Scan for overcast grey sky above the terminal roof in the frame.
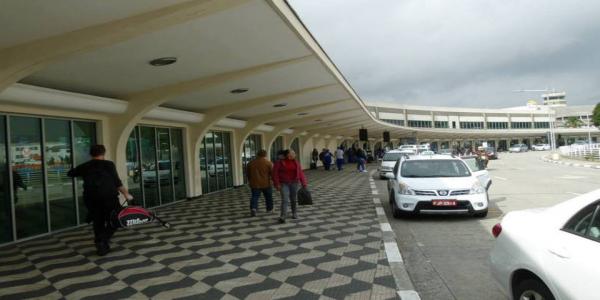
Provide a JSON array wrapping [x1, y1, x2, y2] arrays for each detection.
[[288, 0, 600, 108]]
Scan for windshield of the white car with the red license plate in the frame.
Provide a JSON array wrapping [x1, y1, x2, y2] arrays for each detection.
[[401, 159, 471, 178]]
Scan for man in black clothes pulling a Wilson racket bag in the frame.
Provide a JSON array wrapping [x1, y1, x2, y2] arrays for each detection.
[[67, 145, 133, 256]]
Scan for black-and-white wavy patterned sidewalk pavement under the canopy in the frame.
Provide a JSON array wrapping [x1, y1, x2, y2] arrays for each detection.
[[0, 168, 397, 299]]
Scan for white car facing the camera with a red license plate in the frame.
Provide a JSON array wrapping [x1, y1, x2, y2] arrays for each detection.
[[385, 155, 488, 218]]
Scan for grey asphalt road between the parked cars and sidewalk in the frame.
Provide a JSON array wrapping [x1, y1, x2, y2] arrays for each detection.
[[375, 152, 600, 300]]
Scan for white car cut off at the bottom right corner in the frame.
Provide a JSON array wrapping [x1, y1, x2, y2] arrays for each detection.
[[490, 190, 600, 300]]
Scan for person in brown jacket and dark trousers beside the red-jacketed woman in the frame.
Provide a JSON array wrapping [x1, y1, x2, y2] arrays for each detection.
[[246, 149, 273, 217]]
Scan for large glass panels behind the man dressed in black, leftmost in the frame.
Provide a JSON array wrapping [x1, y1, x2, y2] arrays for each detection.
[[0, 115, 96, 243]]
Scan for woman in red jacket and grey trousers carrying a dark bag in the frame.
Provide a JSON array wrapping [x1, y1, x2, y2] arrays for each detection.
[[273, 150, 306, 223]]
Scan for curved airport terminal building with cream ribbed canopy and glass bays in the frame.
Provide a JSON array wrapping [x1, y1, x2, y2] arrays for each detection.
[[0, 0, 598, 244]]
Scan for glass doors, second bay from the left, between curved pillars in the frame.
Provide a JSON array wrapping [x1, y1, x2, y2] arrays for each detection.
[[125, 126, 186, 207]]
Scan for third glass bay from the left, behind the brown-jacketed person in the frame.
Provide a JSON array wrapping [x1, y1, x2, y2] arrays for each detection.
[[200, 131, 233, 193]]
